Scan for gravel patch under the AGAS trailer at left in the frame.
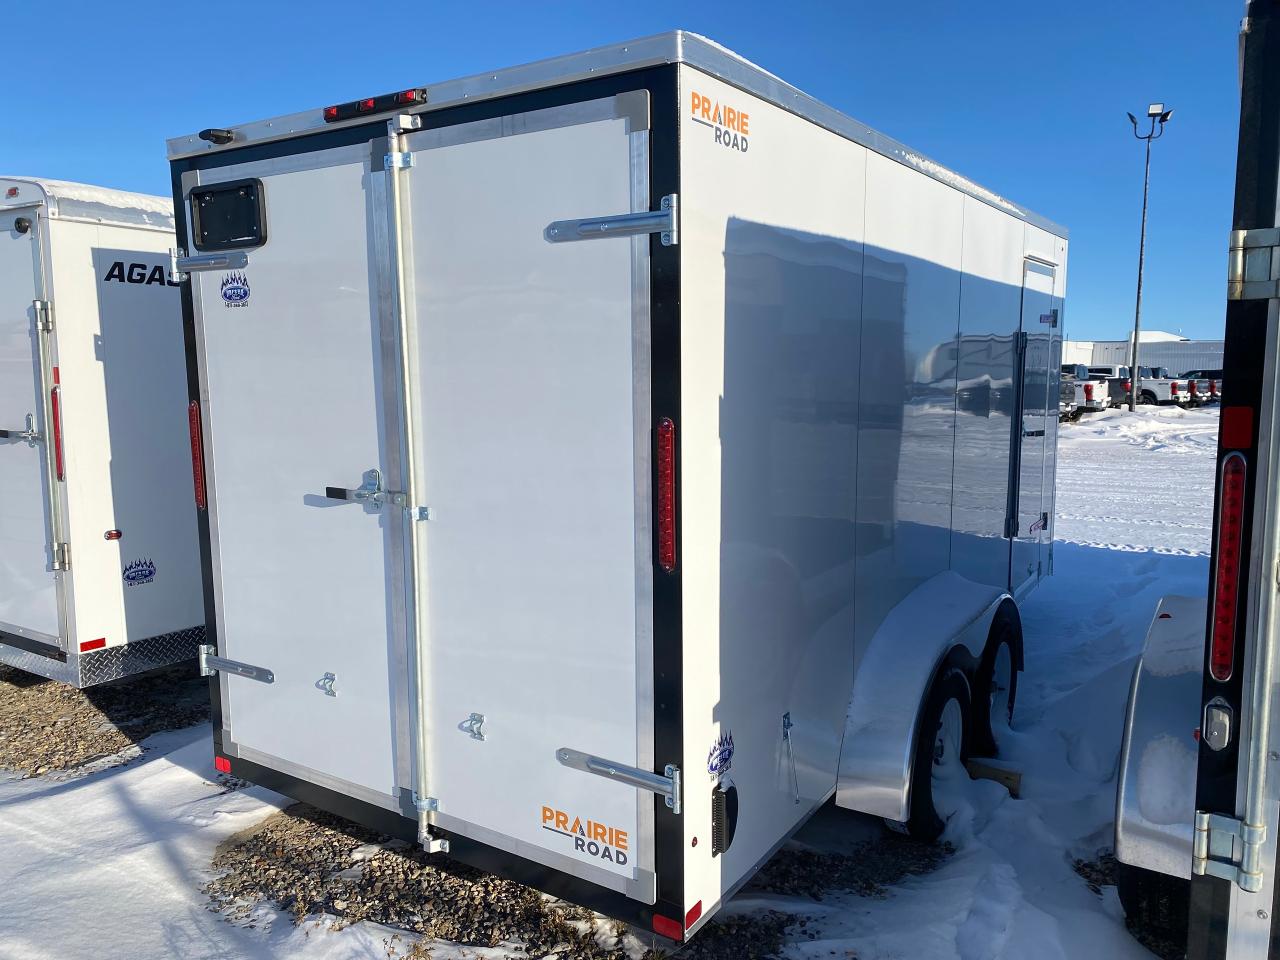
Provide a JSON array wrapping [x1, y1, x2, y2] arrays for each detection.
[[0, 664, 209, 777]]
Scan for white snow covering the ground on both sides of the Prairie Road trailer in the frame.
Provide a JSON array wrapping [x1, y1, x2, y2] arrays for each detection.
[[0, 408, 1217, 960]]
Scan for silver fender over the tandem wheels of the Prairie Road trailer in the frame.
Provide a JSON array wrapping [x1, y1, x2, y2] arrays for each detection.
[[836, 571, 1020, 822]]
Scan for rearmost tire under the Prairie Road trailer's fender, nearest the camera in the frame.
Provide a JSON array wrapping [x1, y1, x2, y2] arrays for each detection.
[[906, 667, 972, 844]]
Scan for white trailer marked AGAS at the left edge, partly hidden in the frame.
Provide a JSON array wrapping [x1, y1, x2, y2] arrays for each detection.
[[0, 177, 205, 687]]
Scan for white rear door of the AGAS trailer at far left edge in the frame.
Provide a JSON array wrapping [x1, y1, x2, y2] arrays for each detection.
[[0, 206, 61, 649]]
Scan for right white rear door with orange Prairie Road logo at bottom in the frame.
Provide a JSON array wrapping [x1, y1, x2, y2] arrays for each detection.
[[407, 93, 658, 902]]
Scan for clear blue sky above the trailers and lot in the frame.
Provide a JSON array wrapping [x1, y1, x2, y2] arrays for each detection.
[[0, 0, 1243, 339]]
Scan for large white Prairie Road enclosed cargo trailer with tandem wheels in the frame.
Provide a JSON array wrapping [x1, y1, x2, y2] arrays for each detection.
[[169, 33, 1066, 938]]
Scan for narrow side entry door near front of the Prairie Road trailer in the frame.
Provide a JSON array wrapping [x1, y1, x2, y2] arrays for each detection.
[[1009, 260, 1057, 593]]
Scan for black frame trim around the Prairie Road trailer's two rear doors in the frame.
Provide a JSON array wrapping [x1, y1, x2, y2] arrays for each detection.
[[170, 64, 685, 931]]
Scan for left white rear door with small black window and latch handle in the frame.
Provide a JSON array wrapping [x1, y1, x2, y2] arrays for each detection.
[[183, 145, 404, 809]]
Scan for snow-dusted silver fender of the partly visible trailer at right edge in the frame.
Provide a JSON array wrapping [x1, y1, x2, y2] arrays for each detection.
[[1115, 596, 1207, 879]]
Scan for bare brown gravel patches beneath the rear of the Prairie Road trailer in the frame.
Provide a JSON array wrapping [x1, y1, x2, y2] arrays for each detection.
[[205, 804, 950, 960]]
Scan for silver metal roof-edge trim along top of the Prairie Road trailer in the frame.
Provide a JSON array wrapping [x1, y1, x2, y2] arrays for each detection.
[[168, 31, 1068, 238]]
